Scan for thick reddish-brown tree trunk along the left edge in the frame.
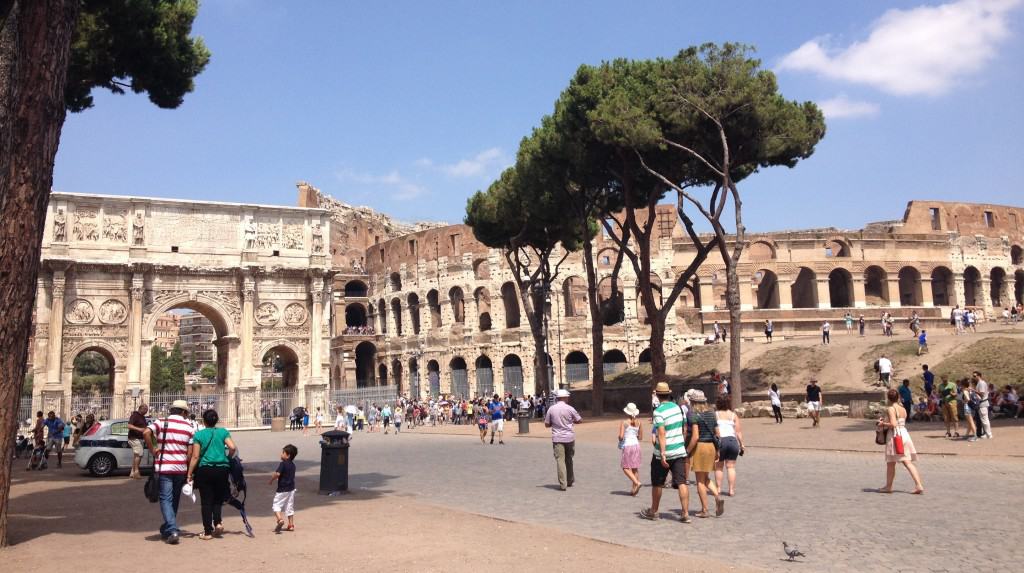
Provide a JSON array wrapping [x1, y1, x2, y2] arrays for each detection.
[[0, 0, 80, 545]]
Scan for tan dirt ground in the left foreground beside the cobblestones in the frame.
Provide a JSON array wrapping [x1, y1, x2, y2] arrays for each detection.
[[0, 464, 750, 573]]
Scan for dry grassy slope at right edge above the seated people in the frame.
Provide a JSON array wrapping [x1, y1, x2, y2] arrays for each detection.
[[932, 338, 1024, 388]]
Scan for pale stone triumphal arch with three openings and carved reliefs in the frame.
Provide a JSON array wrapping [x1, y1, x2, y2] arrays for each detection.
[[32, 192, 332, 420]]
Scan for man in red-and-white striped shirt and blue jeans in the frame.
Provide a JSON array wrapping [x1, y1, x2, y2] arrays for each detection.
[[142, 400, 196, 545]]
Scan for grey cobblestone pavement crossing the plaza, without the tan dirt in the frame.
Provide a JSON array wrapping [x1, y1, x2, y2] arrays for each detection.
[[238, 430, 1024, 571]]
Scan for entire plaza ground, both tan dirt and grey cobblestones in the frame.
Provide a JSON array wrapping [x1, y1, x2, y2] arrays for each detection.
[[4, 420, 1024, 571]]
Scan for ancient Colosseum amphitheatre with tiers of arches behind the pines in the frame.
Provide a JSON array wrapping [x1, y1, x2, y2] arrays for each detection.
[[309, 184, 1024, 403]]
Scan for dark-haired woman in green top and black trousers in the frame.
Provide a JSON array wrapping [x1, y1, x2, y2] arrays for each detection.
[[188, 410, 234, 540]]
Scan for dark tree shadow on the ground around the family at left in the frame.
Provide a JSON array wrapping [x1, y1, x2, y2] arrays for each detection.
[[8, 468, 397, 545]]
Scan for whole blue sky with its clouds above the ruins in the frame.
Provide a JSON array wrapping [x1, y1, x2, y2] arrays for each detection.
[[54, 0, 1024, 230]]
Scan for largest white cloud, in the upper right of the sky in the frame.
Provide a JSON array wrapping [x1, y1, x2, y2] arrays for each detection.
[[778, 0, 1022, 95]]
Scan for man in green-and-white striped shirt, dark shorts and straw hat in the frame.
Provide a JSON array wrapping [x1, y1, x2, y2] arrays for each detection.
[[640, 382, 697, 523]]
